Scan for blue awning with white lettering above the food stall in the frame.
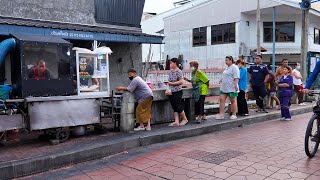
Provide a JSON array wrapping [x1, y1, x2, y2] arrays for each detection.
[[0, 16, 163, 44]]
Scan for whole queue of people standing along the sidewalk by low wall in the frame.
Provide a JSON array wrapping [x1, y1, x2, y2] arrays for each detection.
[[116, 55, 305, 131]]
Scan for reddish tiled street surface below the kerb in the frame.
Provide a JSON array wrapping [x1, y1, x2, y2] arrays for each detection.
[[18, 113, 320, 180]]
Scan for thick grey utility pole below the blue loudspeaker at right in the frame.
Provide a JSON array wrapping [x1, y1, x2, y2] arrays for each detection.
[[301, 9, 309, 82]]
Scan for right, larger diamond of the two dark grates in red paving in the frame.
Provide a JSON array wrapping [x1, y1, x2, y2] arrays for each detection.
[[199, 150, 244, 164]]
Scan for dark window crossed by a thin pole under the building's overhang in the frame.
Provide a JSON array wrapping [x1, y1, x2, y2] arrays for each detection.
[[263, 22, 295, 42]]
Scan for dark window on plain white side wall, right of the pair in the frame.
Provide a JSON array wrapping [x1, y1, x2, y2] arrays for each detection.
[[211, 23, 236, 45]]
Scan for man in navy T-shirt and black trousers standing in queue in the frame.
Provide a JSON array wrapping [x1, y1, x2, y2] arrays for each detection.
[[248, 55, 269, 113]]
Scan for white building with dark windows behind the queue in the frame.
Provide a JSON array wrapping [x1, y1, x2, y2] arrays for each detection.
[[164, 0, 320, 69]]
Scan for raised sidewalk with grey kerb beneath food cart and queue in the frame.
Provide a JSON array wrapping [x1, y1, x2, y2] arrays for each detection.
[[0, 104, 312, 179]]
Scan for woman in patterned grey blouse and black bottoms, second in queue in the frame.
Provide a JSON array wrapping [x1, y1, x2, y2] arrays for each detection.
[[167, 58, 188, 126]]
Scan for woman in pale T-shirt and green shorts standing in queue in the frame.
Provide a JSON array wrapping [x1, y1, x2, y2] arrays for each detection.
[[216, 56, 240, 119]]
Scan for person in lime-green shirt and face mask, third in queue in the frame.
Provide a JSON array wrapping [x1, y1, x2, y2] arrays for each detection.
[[184, 60, 209, 123]]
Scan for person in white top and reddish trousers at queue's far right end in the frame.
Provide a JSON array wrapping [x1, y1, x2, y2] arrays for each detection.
[[292, 63, 306, 106]]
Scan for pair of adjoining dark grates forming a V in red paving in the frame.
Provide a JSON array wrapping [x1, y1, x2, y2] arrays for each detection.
[[181, 150, 244, 164]]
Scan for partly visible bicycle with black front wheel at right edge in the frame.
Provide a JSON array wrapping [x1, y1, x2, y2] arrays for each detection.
[[304, 92, 320, 158]]
